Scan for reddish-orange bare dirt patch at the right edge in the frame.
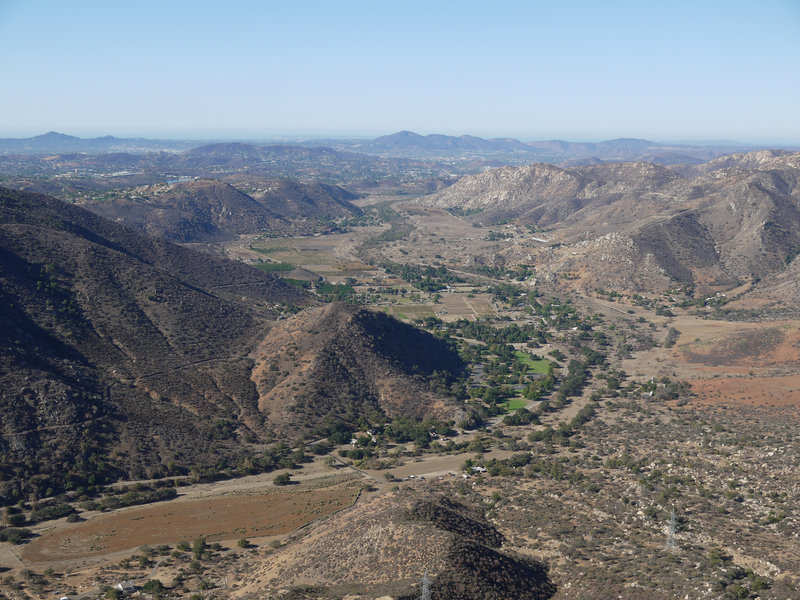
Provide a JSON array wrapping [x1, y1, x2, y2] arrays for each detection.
[[689, 374, 800, 407]]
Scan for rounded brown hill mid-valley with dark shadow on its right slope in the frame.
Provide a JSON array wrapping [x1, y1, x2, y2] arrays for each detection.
[[253, 304, 466, 437]]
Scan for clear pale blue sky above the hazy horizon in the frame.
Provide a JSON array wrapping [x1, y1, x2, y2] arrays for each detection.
[[0, 0, 800, 145]]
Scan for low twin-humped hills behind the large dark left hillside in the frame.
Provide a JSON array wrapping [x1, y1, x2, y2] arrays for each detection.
[[83, 179, 361, 243]]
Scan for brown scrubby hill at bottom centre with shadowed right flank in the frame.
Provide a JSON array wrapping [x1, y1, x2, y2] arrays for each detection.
[[234, 493, 555, 600]]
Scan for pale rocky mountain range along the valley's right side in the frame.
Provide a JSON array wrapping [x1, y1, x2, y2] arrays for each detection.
[[421, 151, 800, 291]]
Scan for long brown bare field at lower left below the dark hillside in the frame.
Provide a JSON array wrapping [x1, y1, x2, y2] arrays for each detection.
[[21, 482, 360, 563]]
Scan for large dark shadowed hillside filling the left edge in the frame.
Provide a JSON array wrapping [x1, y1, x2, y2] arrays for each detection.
[[0, 190, 309, 499]]
